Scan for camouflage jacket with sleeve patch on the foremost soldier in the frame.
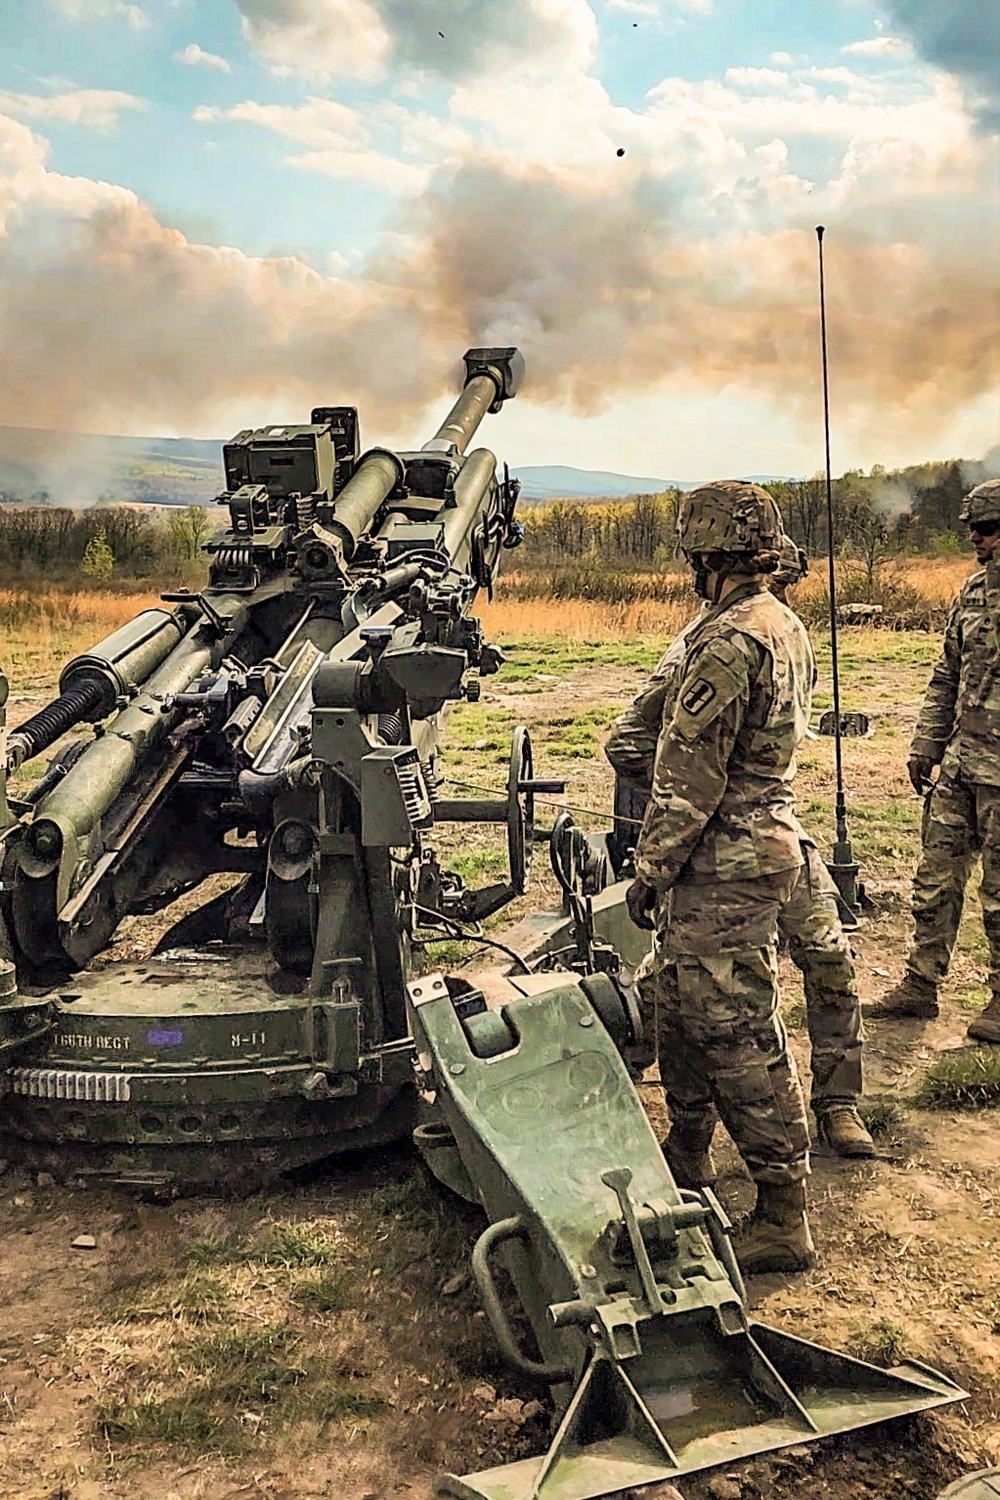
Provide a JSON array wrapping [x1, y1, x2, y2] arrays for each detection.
[[606, 584, 816, 893]]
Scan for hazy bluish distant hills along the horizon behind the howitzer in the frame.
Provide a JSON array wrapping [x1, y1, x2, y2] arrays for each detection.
[[0, 428, 797, 506]]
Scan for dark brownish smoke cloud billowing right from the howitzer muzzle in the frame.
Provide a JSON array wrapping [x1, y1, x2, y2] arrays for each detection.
[[394, 165, 1000, 432]]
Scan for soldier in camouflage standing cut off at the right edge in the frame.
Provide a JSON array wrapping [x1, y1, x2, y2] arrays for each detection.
[[868, 479, 1000, 1043]]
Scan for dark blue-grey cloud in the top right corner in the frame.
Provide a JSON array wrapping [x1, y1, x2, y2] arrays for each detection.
[[889, 0, 1000, 131]]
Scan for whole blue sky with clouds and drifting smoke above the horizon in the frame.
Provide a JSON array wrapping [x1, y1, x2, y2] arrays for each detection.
[[0, 0, 1000, 477]]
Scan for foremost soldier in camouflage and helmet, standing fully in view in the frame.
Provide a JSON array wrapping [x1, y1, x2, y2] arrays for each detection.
[[614, 480, 816, 1272]]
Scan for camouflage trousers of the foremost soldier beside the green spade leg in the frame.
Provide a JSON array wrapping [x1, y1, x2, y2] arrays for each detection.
[[642, 870, 810, 1184]]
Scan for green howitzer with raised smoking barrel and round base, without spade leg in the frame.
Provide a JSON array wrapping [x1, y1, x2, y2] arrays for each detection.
[[0, 348, 560, 1191]]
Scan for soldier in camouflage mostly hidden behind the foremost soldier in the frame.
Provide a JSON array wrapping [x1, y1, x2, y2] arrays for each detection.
[[604, 537, 876, 1164]]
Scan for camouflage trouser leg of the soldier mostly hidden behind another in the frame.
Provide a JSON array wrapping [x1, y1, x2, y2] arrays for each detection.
[[778, 843, 864, 1110]]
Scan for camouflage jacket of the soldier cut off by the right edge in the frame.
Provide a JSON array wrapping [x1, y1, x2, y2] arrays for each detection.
[[910, 563, 1000, 786]]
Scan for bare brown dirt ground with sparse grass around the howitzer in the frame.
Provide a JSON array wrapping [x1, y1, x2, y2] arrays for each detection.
[[0, 633, 1000, 1500]]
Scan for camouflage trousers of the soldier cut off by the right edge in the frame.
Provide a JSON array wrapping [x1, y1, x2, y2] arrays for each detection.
[[907, 779, 1000, 995]]
